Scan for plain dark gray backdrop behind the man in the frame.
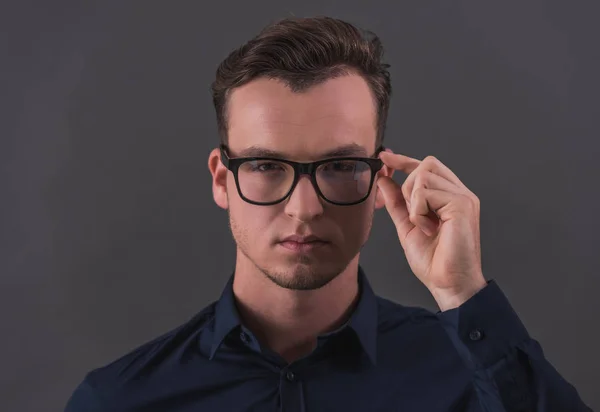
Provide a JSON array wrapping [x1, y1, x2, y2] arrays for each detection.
[[0, 0, 600, 411]]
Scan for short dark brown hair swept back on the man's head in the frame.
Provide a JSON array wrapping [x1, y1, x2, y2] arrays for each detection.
[[211, 17, 392, 146]]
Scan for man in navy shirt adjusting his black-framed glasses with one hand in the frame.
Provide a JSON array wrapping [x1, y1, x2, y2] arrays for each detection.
[[66, 14, 590, 412]]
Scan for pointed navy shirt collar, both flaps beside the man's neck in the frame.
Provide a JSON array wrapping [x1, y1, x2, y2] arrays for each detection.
[[210, 265, 378, 364]]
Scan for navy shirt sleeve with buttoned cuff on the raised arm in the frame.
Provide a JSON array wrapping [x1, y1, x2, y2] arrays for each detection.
[[437, 280, 592, 412]]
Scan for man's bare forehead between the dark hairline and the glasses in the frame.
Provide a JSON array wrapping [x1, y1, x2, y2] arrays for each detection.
[[228, 76, 377, 160]]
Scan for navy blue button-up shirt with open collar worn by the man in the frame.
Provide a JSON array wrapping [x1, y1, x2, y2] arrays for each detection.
[[66, 268, 591, 412]]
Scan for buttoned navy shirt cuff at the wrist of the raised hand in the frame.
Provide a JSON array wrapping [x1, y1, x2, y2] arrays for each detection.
[[437, 279, 530, 367]]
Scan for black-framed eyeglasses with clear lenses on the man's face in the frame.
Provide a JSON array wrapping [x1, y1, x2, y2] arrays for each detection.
[[220, 145, 385, 206]]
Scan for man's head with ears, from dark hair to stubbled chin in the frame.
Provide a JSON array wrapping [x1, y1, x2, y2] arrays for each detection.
[[209, 18, 391, 289]]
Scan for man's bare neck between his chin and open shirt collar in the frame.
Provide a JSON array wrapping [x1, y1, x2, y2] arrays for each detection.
[[233, 256, 358, 363]]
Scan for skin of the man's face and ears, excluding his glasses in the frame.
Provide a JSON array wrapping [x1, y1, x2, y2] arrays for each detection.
[[209, 75, 391, 290]]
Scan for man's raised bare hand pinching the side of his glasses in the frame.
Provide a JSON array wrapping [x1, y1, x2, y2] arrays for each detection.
[[377, 149, 487, 311]]
